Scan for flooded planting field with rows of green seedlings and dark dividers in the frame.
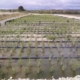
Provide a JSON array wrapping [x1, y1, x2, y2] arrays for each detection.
[[0, 14, 80, 78]]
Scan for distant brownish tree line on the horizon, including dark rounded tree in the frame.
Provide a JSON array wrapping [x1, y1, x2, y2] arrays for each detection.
[[0, 6, 80, 14]]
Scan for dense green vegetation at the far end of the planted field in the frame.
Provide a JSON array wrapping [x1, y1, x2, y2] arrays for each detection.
[[6, 15, 78, 24]]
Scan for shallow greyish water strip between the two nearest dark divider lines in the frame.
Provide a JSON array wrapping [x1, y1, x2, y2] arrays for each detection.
[[0, 47, 80, 57]]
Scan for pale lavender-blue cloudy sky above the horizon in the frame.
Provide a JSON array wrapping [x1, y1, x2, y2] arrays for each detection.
[[0, 0, 80, 10]]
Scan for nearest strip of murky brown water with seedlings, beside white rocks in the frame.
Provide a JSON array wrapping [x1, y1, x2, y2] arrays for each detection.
[[1, 58, 80, 78]]
